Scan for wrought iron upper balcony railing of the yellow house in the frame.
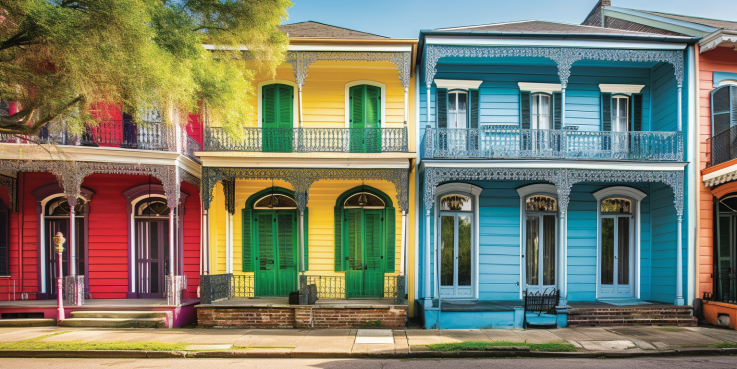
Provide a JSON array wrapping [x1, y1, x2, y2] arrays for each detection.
[[205, 127, 408, 153]]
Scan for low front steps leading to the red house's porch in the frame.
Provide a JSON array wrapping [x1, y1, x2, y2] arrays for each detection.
[[58, 311, 168, 328]]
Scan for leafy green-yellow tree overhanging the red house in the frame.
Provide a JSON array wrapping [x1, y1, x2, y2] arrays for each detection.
[[0, 0, 292, 135]]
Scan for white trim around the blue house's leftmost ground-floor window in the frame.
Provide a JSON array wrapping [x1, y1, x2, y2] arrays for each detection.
[[434, 182, 483, 300]]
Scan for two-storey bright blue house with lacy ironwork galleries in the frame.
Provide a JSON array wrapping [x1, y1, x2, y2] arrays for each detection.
[[416, 21, 697, 329]]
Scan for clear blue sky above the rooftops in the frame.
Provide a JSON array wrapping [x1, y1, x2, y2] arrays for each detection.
[[287, 0, 737, 38]]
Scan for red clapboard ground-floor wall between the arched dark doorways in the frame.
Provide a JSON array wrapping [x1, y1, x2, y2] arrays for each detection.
[[0, 173, 200, 299]]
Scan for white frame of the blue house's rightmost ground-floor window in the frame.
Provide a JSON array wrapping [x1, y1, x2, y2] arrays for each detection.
[[593, 186, 647, 300]]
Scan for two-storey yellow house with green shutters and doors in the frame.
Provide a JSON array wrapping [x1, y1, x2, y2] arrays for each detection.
[[198, 22, 417, 327]]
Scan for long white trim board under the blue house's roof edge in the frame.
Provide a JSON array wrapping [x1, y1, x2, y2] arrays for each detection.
[[425, 35, 688, 50]]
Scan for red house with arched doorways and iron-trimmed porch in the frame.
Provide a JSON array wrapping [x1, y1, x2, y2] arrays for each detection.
[[0, 103, 203, 327]]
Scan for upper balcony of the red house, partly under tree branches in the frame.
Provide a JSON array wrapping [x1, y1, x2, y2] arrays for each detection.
[[0, 120, 200, 162]]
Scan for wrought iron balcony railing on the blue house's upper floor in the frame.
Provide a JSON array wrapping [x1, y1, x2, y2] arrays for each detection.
[[420, 125, 683, 161]]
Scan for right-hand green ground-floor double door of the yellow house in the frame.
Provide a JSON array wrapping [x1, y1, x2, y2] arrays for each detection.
[[345, 209, 384, 298]]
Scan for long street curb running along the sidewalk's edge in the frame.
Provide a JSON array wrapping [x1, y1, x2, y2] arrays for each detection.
[[0, 347, 737, 359]]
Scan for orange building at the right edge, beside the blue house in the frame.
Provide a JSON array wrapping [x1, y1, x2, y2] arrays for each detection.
[[583, 0, 737, 329]]
